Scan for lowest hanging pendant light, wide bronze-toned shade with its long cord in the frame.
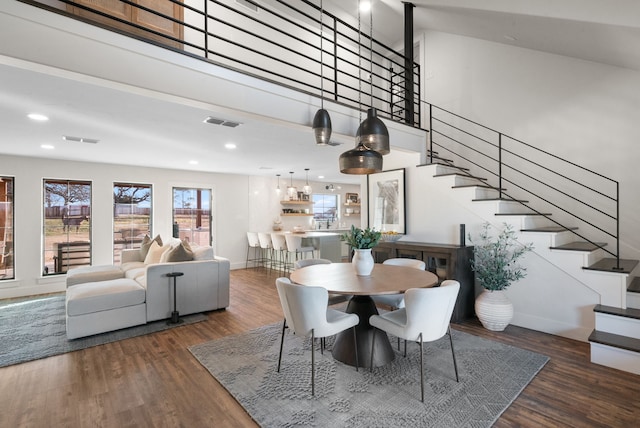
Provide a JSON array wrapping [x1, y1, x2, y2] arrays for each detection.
[[339, 0, 382, 175]]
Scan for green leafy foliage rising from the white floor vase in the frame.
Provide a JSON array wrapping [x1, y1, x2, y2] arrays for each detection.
[[469, 223, 533, 291]]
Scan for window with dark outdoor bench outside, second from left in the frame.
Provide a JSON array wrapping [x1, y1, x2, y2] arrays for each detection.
[[42, 179, 91, 275]]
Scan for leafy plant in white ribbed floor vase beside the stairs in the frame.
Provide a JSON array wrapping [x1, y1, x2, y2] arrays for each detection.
[[469, 223, 533, 331]]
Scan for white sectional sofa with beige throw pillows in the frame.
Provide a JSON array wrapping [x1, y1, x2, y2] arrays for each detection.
[[66, 241, 230, 339]]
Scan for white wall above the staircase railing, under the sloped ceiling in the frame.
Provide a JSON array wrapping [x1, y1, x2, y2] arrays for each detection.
[[421, 32, 640, 259]]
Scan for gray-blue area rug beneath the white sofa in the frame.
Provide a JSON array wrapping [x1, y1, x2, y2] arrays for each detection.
[[0, 294, 207, 367]]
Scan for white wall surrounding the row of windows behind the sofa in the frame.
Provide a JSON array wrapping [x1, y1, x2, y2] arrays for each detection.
[[0, 155, 251, 298]]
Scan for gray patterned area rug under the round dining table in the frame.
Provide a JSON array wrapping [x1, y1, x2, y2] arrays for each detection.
[[189, 323, 549, 428]]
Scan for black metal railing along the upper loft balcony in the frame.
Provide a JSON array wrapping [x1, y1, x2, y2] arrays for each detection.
[[25, 0, 420, 127]]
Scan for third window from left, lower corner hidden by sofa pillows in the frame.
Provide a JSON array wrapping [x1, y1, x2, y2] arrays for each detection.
[[113, 183, 152, 263]]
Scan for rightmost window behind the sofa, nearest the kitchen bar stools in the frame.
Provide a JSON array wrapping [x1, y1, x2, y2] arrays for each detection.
[[173, 187, 213, 246]]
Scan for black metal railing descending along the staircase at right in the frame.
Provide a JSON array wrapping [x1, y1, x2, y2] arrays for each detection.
[[426, 103, 621, 270]]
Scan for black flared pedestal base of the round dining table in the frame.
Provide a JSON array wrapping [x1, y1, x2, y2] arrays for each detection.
[[333, 296, 395, 368]]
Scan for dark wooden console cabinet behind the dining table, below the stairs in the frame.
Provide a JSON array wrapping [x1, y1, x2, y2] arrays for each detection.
[[372, 241, 475, 322]]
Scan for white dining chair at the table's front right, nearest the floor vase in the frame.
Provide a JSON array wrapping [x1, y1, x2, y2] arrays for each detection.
[[369, 280, 460, 402]]
